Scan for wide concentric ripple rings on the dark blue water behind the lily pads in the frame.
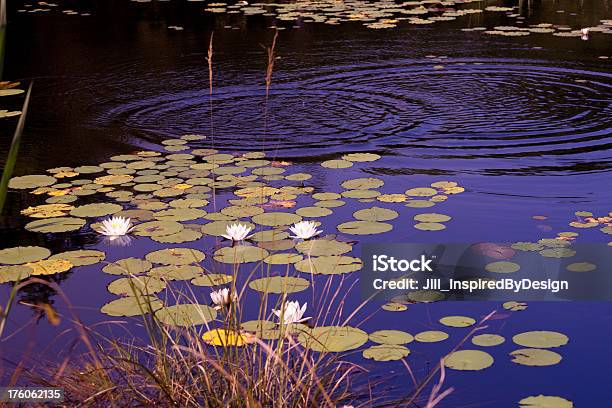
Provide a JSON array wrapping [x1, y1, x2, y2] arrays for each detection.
[[99, 60, 612, 173]]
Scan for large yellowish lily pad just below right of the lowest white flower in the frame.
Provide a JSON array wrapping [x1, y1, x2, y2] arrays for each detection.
[[298, 326, 368, 352]]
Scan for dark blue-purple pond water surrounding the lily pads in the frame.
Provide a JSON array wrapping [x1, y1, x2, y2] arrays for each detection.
[[0, 0, 612, 407]]
